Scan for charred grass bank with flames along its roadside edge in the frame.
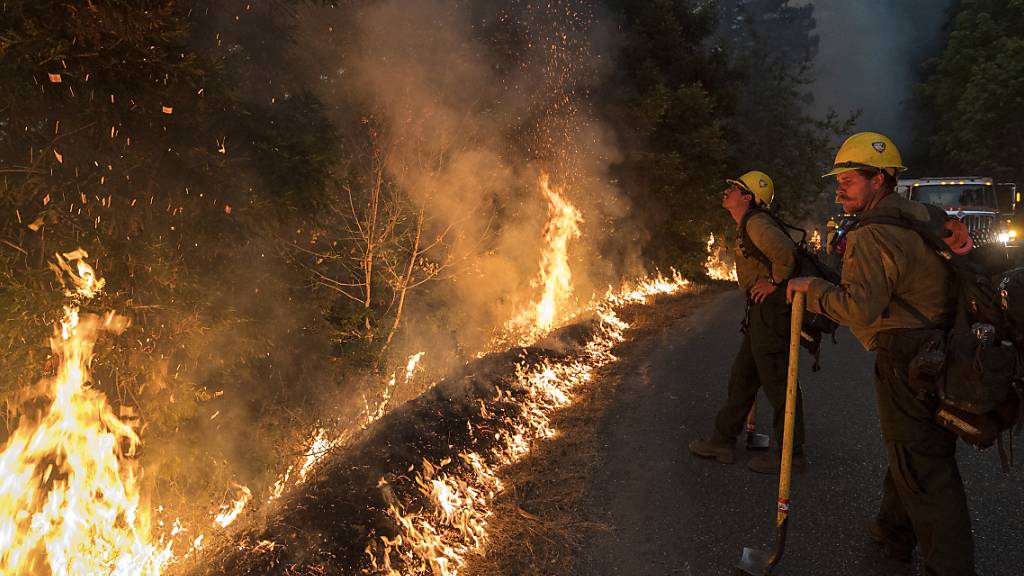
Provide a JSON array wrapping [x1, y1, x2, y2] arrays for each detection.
[[182, 270, 688, 575]]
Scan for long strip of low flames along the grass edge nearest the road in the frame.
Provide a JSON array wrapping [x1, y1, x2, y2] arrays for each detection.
[[366, 271, 690, 576]]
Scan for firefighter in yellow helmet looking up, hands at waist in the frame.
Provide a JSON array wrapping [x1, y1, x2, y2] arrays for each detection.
[[688, 170, 804, 474]]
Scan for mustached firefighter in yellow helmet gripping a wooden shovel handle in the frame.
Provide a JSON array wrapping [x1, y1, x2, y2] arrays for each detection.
[[786, 132, 975, 576]]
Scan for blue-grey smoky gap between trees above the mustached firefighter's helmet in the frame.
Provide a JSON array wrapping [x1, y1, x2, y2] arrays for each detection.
[[803, 0, 952, 155]]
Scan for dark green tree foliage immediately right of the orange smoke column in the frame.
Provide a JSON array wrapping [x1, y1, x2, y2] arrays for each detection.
[[599, 0, 727, 268]]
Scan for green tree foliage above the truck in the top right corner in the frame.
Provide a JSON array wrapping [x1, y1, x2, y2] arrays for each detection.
[[918, 0, 1024, 182]]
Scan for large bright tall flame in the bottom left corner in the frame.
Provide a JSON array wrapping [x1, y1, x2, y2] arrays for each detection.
[[0, 250, 171, 575]]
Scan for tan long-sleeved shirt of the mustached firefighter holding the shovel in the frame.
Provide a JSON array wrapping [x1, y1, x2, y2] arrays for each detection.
[[807, 194, 955, 351]]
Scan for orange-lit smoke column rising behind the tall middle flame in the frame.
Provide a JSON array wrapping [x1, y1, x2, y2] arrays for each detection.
[[299, 0, 638, 361]]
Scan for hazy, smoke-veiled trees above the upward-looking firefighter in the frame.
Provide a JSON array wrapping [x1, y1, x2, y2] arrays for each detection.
[[716, 0, 849, 221]]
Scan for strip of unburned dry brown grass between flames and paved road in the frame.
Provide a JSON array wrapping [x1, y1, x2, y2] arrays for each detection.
[[464, 289, 719, 576]]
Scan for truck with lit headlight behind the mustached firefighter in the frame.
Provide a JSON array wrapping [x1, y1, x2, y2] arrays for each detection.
[[896, 176, 1024, 270]]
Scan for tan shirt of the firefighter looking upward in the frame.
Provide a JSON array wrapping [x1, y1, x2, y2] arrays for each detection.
[[732, 211, 796, 295]]
